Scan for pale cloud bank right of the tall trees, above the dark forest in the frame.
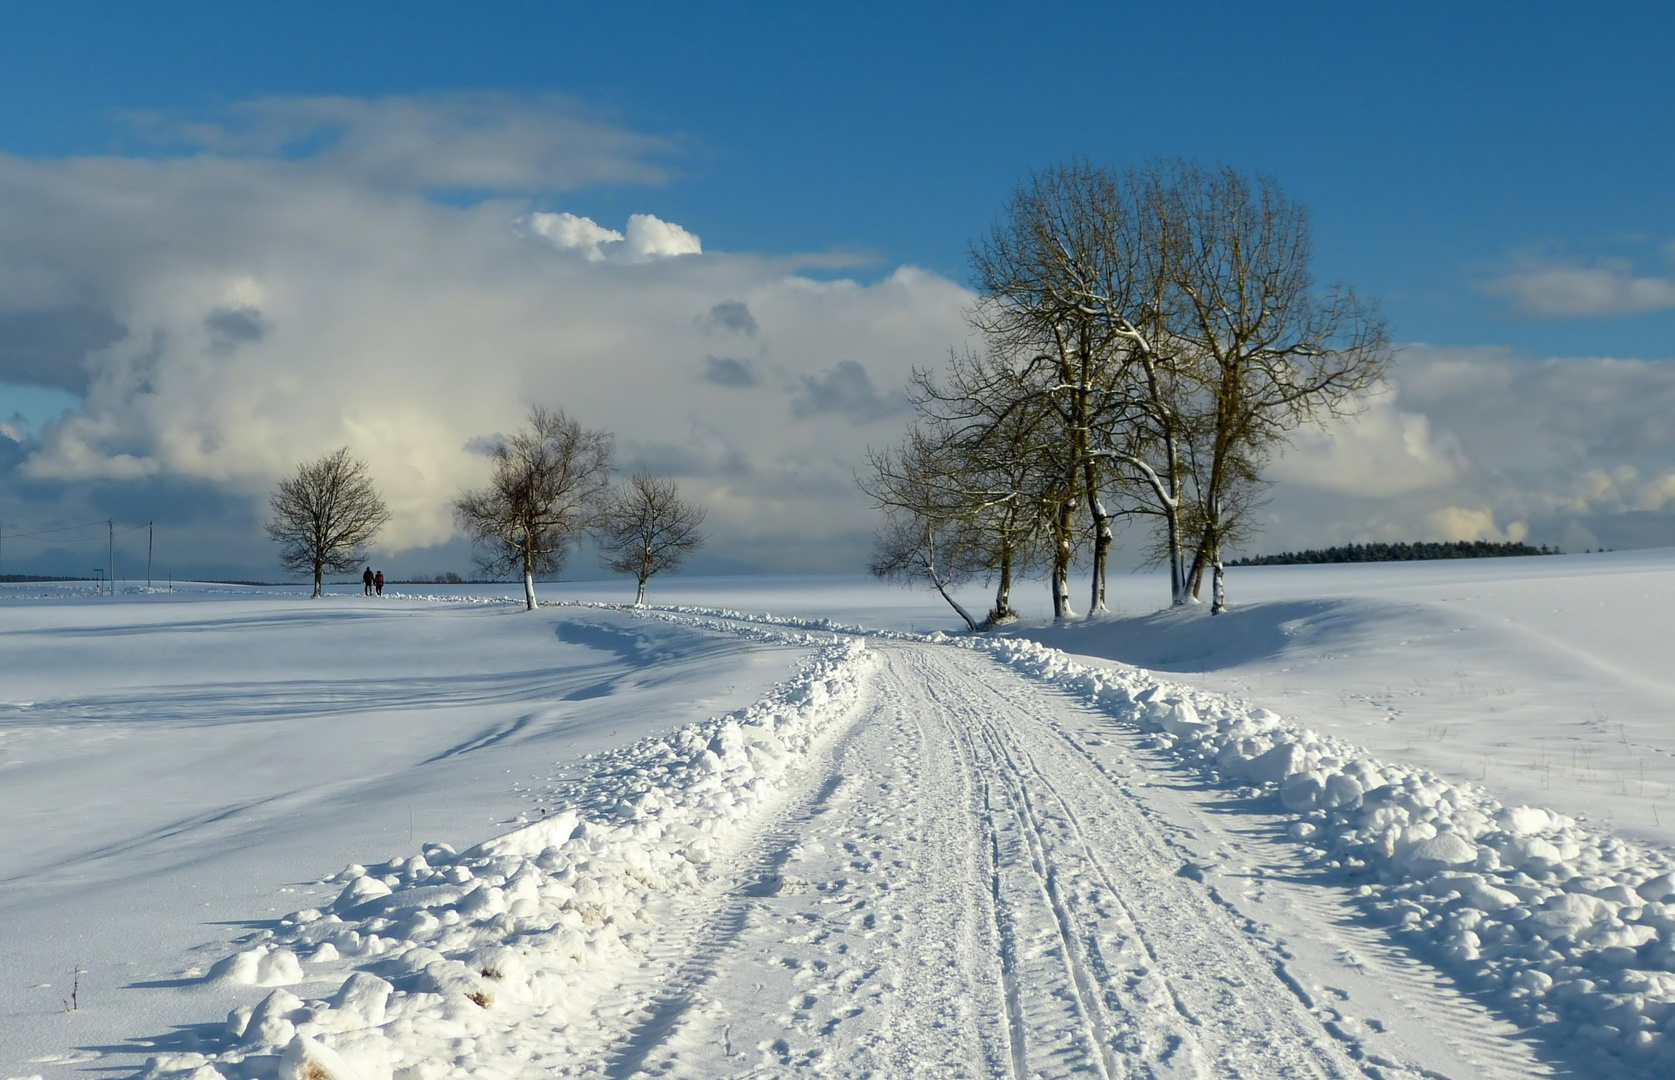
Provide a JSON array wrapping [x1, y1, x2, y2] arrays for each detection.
[[1255, 347, 1675, 551]]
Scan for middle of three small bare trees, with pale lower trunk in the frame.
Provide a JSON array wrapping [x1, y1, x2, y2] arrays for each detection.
[[454, 407, 615, 611]]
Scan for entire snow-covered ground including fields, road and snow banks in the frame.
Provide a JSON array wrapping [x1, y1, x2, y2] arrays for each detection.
[[0, 551, 1675, 1080]]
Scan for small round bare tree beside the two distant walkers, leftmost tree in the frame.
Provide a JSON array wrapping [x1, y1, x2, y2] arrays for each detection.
[[266, 447, 390, 596]]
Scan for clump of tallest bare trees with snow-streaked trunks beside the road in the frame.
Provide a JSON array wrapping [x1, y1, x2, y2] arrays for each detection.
[[972, 162, 1389, 618]]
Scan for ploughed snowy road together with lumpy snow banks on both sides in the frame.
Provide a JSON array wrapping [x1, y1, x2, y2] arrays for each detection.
[[45, 611, 1675, 1080]]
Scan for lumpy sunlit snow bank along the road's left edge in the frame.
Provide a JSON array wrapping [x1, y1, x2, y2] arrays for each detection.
[[146, 638, 873, 1080]]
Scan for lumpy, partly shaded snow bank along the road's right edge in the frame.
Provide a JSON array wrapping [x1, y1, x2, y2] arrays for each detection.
[[984, 640, 1675, 1075]]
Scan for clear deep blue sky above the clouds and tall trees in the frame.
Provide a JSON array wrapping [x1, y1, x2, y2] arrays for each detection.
[[13, 2, 1675, 349]]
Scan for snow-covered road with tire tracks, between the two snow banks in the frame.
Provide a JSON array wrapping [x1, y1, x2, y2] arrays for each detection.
[[566, 643, 1544, 1078]]
